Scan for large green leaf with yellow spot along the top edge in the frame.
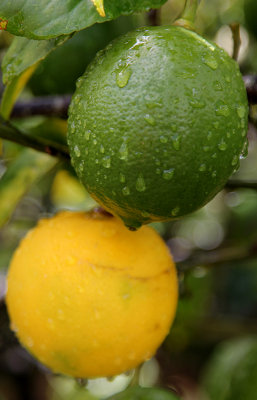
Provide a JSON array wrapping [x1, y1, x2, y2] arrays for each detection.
[[0, 0, 167, 39]]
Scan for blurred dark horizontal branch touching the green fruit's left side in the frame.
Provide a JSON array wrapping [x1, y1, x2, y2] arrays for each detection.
[[11, 95, 71, 118]]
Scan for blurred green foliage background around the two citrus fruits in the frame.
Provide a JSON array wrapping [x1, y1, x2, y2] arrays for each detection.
[[0, 0, 257, 400]]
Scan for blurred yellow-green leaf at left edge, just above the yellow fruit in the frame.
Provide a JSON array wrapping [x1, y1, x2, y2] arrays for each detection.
[[0, 149, 58, 227]]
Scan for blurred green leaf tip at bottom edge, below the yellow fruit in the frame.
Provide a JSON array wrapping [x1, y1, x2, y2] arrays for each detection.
[[105, 386, 179, 400]]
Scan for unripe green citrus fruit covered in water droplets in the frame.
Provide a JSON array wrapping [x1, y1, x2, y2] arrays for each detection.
[[68, 26, 248, 227]]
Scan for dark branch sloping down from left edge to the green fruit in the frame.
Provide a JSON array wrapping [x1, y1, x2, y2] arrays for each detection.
[[0, 117, 70, 160]]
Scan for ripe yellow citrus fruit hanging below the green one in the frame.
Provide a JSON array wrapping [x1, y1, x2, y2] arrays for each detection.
[[7, 212, 178, 378]]
